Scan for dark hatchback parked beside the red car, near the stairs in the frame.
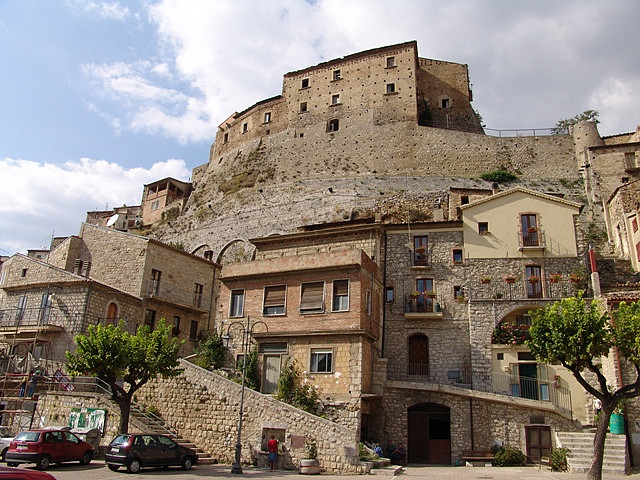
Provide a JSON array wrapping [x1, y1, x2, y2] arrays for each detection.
[[104, 433, 198, 473]]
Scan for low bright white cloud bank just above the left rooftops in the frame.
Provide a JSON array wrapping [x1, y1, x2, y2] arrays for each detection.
[[0, 158, 190, 254]]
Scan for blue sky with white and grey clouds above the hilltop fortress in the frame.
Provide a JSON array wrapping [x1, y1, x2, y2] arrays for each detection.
[[0, 0, 640, 255]]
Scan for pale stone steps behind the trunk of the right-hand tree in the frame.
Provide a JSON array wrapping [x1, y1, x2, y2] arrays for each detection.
[[556, 431, 631, 475]]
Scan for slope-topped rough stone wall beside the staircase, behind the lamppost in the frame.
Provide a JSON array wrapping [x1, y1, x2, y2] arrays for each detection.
[[137, 361, 361, 473]]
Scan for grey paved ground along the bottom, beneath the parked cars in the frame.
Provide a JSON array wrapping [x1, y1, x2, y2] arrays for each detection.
[[7, 460, 640, 480]]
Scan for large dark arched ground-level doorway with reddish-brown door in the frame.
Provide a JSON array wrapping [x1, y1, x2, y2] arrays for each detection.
[[407, 403, 451, 465]]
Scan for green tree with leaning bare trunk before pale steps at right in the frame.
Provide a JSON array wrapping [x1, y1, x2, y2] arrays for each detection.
[[526, 292, 640, 480]]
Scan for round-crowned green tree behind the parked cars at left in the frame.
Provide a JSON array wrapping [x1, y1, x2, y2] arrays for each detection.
[[66, 319, 182, 433]]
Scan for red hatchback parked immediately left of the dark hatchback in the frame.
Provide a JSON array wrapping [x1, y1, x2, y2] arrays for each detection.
[[5, 429, 94, 470]]
